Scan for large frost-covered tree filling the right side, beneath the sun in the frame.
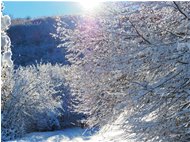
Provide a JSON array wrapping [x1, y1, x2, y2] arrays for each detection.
[[57, 2, 190, 141]]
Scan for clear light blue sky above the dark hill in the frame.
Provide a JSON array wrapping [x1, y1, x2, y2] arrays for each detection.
[[3, 1, 82, 18]]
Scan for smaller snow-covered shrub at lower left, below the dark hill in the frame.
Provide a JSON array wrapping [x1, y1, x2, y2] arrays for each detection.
[[2, 64, 71, 140]]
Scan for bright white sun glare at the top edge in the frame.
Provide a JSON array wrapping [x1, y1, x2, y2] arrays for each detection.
[[79, 0, 100, 10]]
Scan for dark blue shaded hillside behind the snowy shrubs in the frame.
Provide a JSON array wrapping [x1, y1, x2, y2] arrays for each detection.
[[8, 16, 75, 67]]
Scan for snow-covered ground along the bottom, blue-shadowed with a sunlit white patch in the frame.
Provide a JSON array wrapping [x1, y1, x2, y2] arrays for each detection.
[[8, 112, 134, 142]]
